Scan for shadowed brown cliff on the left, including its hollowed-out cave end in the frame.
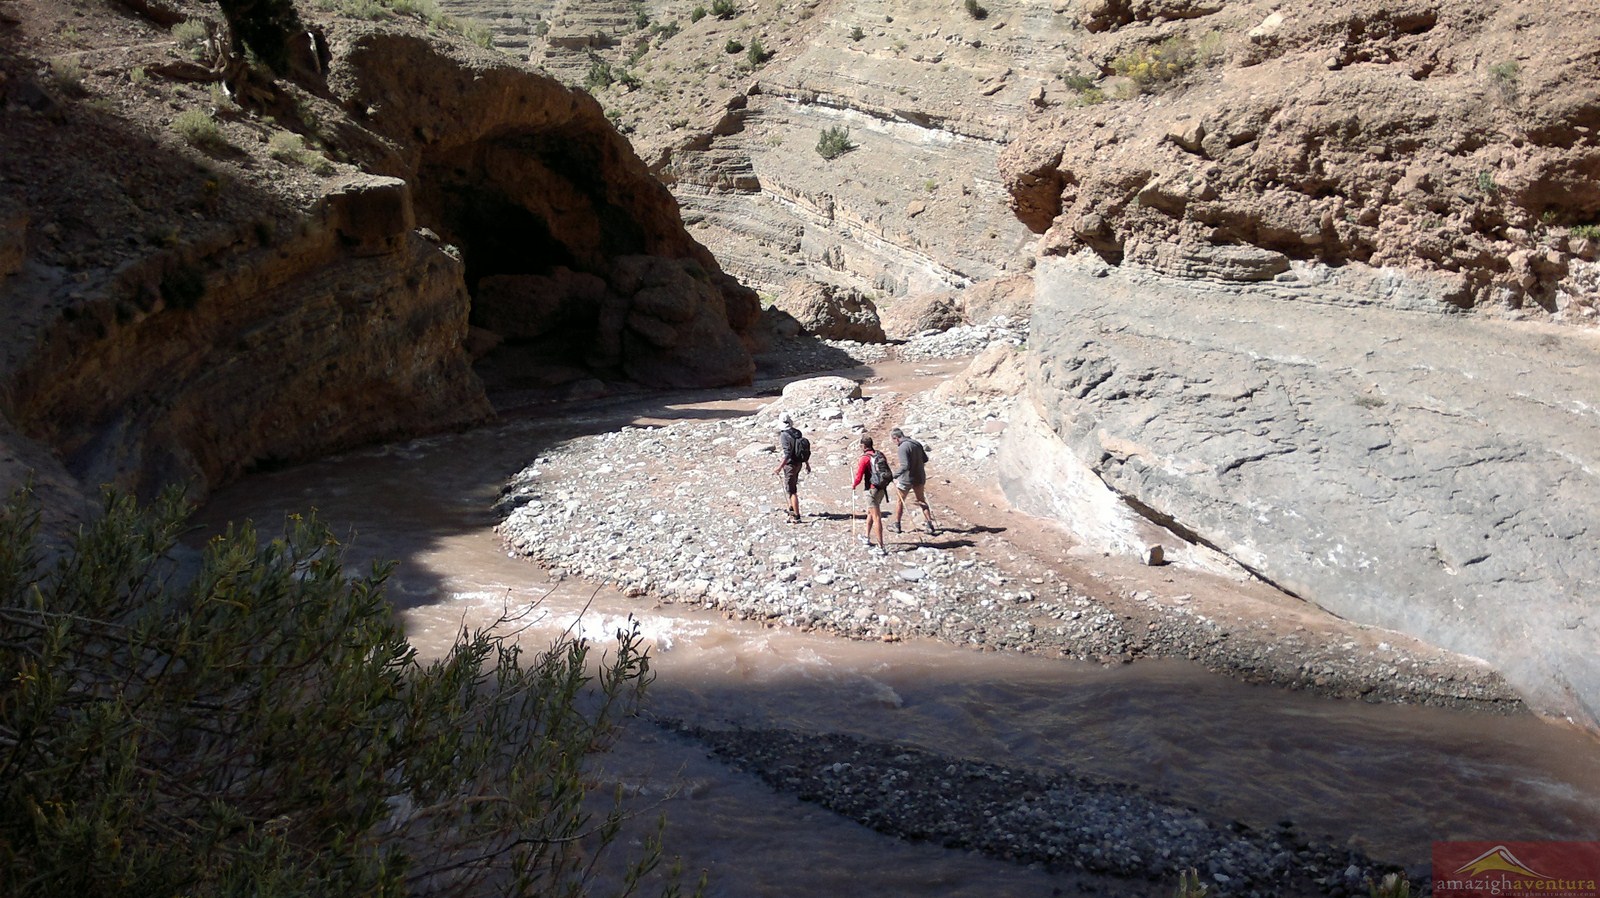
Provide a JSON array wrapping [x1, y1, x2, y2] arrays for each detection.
[[0, 18, 760, 504]]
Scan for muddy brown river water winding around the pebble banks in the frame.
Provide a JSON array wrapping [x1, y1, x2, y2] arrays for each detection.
[[202, 379, 1600, 898]]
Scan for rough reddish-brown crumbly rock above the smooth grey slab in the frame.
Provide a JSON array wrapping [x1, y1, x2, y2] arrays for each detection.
[[1002, 0, 1600, 322]]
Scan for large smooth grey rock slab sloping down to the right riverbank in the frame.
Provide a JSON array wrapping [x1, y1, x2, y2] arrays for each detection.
[[1003, 261, 1600, 727]]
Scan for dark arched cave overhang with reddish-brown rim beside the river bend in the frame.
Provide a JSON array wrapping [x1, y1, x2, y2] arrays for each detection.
[[333, 32, 760, 387]]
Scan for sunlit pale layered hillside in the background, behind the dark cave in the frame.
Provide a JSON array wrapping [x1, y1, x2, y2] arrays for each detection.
[[446, 0, 1049, 306]]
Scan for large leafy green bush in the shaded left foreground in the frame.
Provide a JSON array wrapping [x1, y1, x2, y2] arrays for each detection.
[[0, 491, 677, 898]]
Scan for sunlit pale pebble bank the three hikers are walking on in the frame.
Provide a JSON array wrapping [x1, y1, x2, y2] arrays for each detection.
[[499, 323, 1517, 709]]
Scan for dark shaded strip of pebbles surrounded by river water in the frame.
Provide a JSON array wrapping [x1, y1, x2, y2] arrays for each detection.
[[678, 725, 1426, 898]]
